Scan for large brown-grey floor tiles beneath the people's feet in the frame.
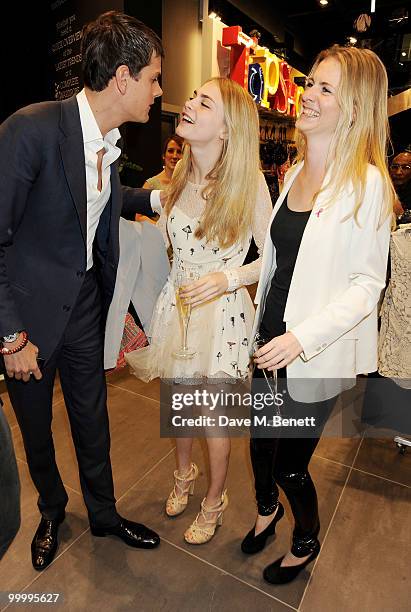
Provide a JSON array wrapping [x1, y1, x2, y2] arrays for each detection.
[[0, 370, 411, 612]]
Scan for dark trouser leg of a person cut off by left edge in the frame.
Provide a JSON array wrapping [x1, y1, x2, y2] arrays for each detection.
[[0, 399, 20, 559]]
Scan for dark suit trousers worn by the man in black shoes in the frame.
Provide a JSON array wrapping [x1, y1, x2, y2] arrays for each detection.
[[6, 268, 120, 527]]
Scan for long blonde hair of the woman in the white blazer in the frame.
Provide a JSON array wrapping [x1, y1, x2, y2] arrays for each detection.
[[296, 45, 395, 223]]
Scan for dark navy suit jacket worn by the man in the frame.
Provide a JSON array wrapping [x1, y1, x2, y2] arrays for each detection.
[[0, 97, 152, 359]]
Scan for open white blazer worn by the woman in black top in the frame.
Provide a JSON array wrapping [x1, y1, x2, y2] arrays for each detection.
[[252, 162, 391, 402]]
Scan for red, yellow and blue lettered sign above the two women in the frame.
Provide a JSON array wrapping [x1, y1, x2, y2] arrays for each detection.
[[222, 26, 304, 117]]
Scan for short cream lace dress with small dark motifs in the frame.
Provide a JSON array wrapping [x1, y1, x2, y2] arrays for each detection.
[[126, 174, 272, 381]]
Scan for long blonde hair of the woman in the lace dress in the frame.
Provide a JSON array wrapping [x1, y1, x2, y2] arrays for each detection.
[[165, 77, 260, 248]]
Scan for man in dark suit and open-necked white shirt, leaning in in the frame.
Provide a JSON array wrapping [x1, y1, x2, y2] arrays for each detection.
[[0, 11, 163, 570]]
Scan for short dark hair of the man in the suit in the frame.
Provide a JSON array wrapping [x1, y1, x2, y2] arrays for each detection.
[[81, 11, 164, 91]]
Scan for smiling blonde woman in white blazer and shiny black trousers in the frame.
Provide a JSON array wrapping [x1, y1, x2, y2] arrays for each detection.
[[241, 45, 393, 584]]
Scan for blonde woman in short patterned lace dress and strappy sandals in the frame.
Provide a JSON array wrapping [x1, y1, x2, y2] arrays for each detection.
[[127, 78, 272, 544]]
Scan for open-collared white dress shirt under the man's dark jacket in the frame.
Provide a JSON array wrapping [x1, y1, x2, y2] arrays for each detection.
[[76, 89, 161, 270]]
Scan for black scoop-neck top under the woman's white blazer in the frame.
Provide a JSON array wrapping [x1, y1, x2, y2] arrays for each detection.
[[260, 196, 311, 339]]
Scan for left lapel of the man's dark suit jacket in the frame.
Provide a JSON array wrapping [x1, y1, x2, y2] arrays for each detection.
[[60, 96, 87, 244]]
